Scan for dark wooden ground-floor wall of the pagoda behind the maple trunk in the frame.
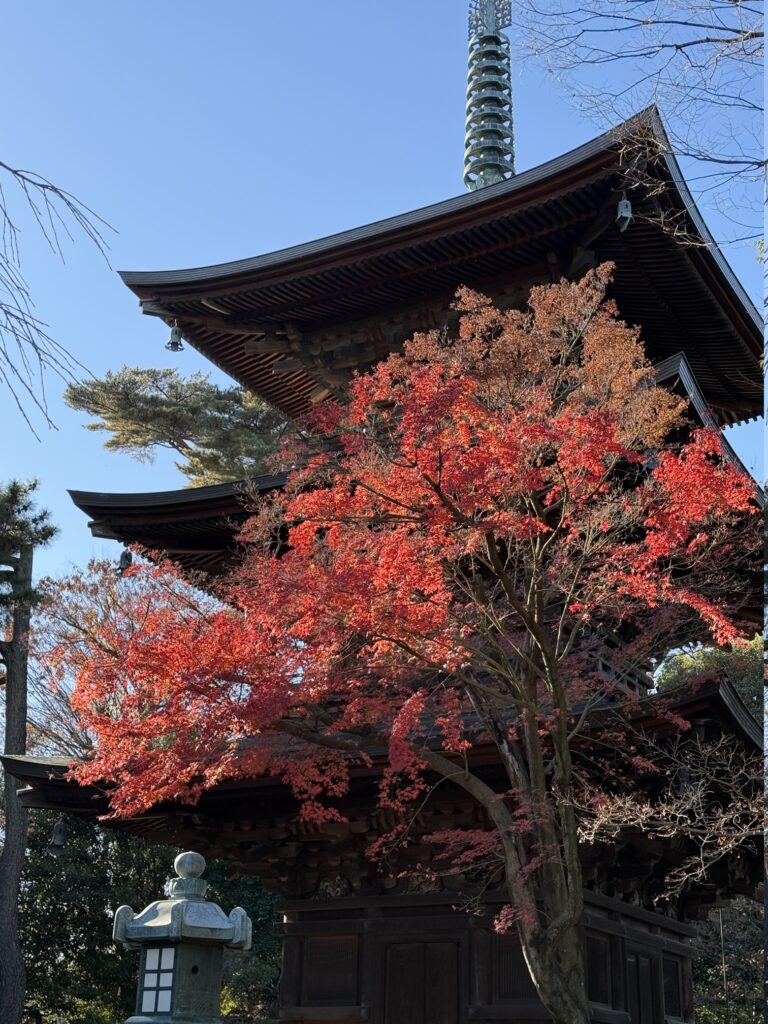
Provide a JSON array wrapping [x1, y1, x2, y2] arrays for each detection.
[[281, 895, 692, 1024]]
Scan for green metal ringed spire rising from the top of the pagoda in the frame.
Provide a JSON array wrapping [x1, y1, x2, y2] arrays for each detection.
[[464, 0, 515, 189]]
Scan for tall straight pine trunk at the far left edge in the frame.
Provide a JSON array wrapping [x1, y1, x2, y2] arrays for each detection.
[[0, 547, 32, 1024]]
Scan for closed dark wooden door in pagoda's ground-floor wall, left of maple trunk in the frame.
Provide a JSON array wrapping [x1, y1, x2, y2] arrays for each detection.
[[383, 940, 460, 1024]]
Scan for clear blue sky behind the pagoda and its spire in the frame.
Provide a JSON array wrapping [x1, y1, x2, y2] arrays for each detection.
[[0, 0, 762, 573]]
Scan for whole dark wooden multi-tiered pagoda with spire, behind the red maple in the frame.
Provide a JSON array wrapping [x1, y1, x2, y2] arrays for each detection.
[[3, 0, 762, 1024]]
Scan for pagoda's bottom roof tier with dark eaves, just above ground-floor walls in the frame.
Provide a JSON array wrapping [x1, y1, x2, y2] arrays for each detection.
[[2, 680, 762, 916]]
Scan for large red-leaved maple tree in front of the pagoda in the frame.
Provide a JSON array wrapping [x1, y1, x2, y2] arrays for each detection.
[[69, 266, 755, 1024]]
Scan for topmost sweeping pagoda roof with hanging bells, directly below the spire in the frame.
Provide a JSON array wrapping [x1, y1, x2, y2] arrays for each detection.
[[121, 109, 762, 424]]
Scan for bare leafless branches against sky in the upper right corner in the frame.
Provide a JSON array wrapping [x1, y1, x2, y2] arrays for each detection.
[[519, 0, 765, 242]]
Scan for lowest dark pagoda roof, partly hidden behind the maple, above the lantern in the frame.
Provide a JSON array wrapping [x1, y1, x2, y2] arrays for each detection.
[[0, 680, 762, 902]]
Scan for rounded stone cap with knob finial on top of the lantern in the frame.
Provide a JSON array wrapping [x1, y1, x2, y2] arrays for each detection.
[[113, 852, 252, 949]]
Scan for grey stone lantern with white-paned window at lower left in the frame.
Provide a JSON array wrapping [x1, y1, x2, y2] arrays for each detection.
[[113, 853, 251, 1024]]
